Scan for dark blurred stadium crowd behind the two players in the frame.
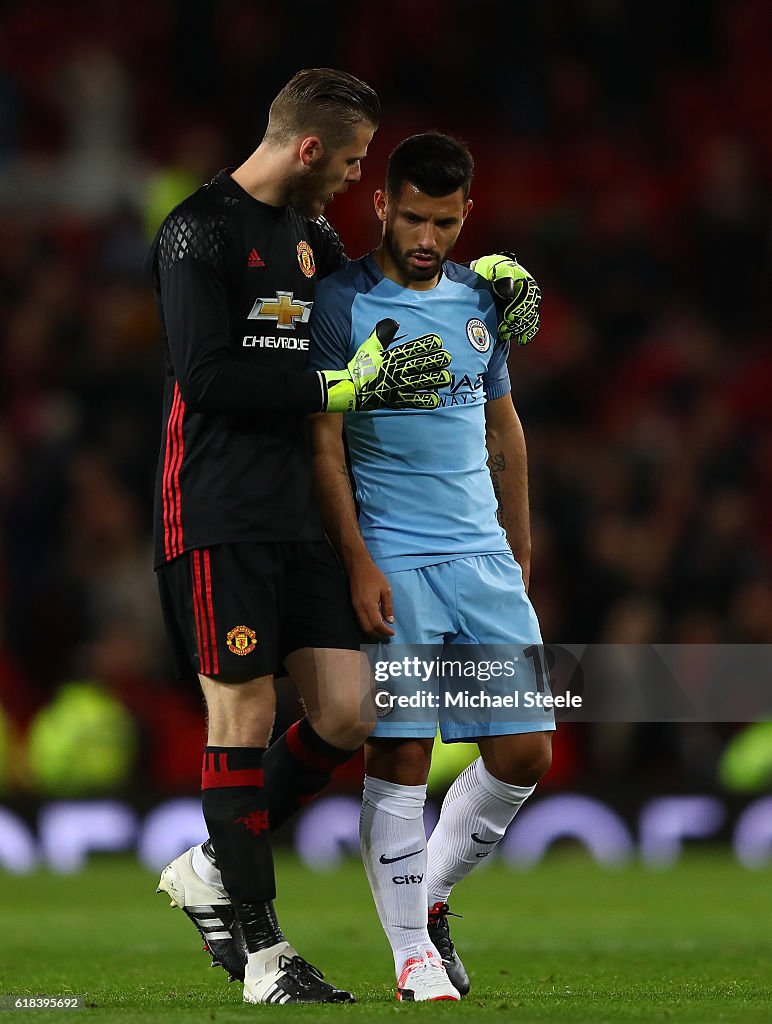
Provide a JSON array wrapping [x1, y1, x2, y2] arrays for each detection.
[[0, 0, 772, 796]]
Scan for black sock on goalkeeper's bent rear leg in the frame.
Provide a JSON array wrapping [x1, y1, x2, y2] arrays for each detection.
[[262, 718, 356, 831]]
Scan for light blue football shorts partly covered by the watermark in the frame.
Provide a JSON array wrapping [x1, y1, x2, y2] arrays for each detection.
[[368, 553, 555, 742]]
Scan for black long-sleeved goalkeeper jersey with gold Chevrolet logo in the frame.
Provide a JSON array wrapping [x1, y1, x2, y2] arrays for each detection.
[[149, 171, 346, 567]]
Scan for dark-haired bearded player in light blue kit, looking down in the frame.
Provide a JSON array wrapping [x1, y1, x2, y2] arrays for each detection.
[[311, 132, 554, 1000]]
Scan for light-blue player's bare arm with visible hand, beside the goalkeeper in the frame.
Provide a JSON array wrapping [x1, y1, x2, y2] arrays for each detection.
[[311, 415, 394, 637]]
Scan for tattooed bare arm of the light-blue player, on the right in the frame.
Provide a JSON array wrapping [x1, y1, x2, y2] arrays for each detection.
[[485, 394, 530, 590]]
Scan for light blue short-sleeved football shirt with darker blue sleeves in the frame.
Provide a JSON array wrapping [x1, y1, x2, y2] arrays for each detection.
[[310, 256, 510, 572]]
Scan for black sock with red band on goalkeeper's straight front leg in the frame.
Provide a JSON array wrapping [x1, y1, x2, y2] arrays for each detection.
[[202, 746, 284, 952]]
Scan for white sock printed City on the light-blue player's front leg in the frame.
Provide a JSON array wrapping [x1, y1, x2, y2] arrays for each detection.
[[359, 775, 439, 977]]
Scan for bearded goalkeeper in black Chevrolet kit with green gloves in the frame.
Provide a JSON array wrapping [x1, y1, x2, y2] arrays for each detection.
[[149, 69, 536, 1004]]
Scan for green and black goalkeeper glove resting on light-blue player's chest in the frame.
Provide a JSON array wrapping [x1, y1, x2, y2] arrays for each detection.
[[318, 319, 452, 413]]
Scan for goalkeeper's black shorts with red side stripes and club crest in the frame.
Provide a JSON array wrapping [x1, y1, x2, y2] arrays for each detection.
[[158, 541, 366, 682]]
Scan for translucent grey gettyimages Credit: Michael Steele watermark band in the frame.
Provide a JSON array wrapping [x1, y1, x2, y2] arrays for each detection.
[[362, 644, 772, 731]]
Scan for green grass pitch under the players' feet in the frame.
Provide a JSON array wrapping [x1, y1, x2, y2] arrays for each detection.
[[0, 854, 772, 1024]]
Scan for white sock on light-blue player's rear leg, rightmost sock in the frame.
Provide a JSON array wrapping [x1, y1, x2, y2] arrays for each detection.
[[426, 758, 535, 909]]
